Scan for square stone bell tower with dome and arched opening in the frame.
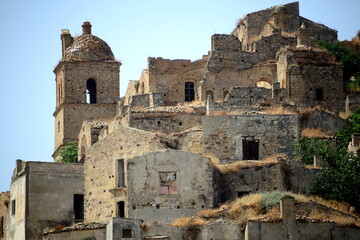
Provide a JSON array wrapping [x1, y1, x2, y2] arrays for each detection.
[[53, 22, 121, 159]]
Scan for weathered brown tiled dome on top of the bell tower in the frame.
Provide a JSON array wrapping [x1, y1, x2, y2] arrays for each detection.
[[65, 34, 115, 62]]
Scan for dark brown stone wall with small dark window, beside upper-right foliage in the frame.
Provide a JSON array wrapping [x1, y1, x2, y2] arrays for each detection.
[[278, 49, 344, 112]]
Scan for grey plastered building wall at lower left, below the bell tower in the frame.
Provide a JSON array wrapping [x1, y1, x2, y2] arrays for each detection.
[[9, 161, 84, 240]]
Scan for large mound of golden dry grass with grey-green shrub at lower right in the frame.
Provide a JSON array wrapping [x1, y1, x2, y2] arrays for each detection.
[[171, 192, 360, 230]]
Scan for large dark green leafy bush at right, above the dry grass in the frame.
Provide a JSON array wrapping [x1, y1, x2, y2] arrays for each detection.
[[295, 108, 360, 211]]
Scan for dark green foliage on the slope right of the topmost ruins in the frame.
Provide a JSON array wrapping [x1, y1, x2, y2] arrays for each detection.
[[317, 41, 360, 91]]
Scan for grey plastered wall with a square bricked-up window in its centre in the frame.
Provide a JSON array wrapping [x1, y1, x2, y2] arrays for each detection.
[[127, 149, 214, 223]]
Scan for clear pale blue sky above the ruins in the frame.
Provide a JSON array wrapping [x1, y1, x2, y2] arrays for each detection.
[[0, 0, 360, 192]]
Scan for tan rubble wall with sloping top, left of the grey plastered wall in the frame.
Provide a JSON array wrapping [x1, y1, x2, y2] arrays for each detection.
[[84, 126, 166, 222]]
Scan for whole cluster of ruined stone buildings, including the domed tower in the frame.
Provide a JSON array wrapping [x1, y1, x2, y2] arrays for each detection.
[[0, 2, 360, 240]]
